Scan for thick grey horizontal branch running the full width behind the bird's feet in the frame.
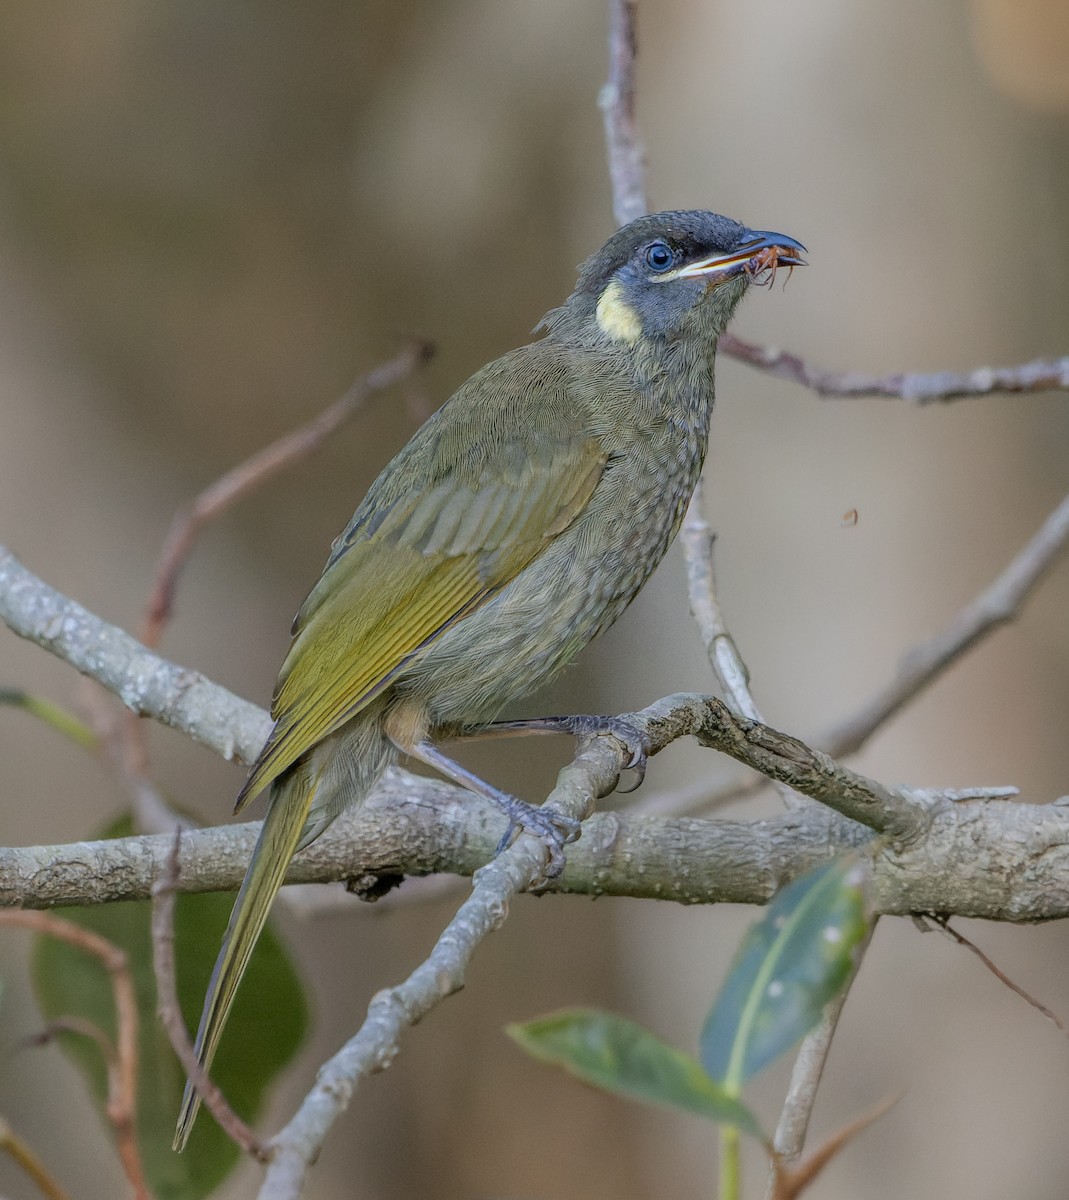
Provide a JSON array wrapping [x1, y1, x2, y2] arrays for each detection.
[[8, 768, 1069, 922]]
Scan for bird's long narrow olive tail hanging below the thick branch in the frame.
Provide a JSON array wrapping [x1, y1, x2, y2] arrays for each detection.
[[174, 770, 318, 1150]]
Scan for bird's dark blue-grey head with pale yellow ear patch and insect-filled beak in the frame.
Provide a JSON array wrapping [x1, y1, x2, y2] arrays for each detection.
[[554, 211, 805, 344]]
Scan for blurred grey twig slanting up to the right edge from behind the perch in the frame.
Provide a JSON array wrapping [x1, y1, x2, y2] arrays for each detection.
[[816, 484, 1069, 758]]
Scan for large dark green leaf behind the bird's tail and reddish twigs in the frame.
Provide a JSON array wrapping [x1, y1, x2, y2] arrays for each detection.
[[34, 818, 308, 1200]]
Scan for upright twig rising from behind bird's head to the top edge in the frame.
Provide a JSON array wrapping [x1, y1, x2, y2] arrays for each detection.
[[597, 0, 648, 226]]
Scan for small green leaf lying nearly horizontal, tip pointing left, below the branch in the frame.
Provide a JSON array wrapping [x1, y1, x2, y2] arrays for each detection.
[[506, 1008, 764, 1140]]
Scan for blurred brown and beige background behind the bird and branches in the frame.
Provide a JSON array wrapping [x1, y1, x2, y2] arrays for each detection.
[[0, 0, 1069, 1200]]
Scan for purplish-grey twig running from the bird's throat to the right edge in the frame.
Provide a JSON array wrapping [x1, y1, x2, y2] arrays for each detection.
[[719, 334, 1069, 404]]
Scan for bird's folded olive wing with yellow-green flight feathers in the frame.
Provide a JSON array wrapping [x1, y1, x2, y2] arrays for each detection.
[[238, 396, 608, 809]]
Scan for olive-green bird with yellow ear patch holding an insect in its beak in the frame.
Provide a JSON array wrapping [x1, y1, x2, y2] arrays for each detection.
[[174, 210, 805, 1150]]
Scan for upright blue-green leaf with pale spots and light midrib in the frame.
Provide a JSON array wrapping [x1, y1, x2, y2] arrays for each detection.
[[699, 858, 867, 1096]]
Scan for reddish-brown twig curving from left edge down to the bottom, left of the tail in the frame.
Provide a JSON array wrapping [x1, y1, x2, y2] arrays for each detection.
[[0, 910, 149, 1200]]
